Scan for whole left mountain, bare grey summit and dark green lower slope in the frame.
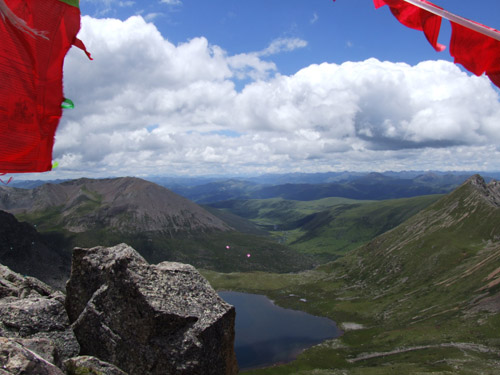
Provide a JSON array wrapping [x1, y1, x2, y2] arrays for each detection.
[[0, 177, 313, 280]]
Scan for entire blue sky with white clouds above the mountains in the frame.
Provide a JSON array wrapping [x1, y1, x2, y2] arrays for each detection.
[[37, 0, 500, 178]]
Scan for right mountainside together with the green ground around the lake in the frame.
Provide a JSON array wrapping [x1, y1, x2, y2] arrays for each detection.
[[202, 176, 500, 375]]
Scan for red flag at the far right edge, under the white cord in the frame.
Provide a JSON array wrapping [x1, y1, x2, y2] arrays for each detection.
[[450, 22, 500, 87]]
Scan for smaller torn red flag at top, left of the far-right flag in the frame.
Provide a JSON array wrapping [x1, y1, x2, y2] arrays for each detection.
[[373, 0, 446, 52]]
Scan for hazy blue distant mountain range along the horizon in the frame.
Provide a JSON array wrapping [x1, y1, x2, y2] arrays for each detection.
[[154, 172, 470, 204]]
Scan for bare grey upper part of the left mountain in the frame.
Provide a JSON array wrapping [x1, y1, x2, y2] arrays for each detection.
[[0, 177, 231, 234]]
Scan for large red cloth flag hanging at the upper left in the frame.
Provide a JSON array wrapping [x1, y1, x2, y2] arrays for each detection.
[[0, 0, 85, 173]]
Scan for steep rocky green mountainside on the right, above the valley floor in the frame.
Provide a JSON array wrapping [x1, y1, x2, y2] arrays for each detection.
[[339, 175, 500, 318]]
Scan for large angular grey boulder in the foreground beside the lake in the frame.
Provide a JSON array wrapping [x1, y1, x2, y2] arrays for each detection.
[[66, 244, 238, 375]]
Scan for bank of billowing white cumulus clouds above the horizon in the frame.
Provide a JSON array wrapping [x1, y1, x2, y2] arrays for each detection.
[[54, 16, 500, 176]]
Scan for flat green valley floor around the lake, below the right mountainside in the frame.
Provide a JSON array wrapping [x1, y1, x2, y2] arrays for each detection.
[[203, 267, 500, 375]]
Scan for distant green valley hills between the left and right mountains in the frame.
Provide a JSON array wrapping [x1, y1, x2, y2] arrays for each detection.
[[212, 195, 441, 263]]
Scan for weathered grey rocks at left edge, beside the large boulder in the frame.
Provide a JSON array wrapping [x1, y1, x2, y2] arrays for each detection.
[[0, 265, 80, 364]]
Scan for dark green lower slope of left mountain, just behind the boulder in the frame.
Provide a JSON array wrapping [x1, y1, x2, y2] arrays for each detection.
[[13, 215, 317, 276]]
